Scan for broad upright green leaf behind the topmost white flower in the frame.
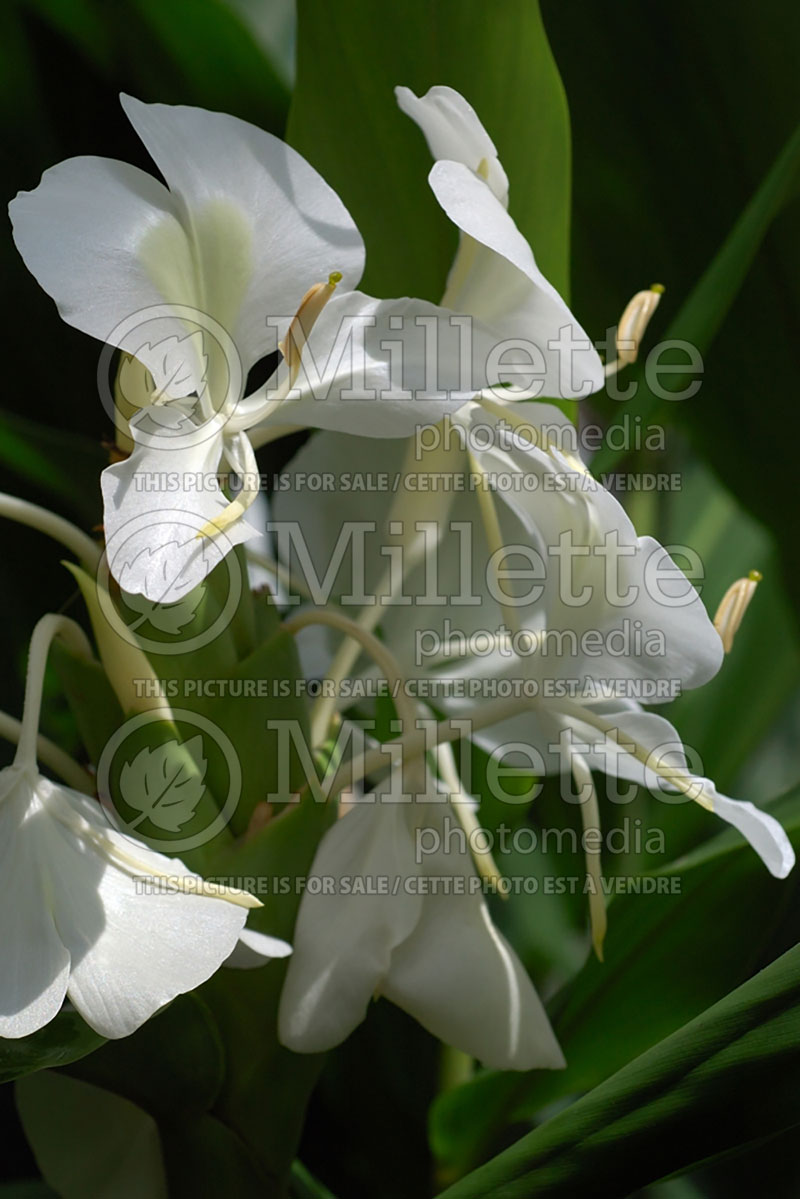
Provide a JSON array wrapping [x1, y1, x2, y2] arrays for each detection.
[[288, 0, 570, 301]]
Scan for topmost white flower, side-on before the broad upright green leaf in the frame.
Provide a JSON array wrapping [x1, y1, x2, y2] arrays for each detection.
[[395, 88, 604, 399]]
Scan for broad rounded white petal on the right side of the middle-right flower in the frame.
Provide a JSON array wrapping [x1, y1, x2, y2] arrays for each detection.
[[458, 404, 723, 703]]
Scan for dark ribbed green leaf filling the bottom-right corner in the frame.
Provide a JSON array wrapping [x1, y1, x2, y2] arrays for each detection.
[[441, 947, 800, 1199]]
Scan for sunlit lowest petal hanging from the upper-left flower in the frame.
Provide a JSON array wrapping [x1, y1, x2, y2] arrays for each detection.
[[101, 405, 257, 603]]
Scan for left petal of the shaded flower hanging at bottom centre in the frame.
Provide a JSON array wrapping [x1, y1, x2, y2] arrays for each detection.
[[278, 802, 422, 1053]]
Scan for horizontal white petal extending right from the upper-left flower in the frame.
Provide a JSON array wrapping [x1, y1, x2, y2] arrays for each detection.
[[265, 290, 506, 438]]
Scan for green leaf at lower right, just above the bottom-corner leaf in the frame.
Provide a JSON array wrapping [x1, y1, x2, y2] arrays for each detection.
[[431, 788, 800, 1176]]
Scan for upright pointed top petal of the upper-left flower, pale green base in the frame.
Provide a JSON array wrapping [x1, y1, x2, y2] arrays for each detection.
[[121, 96, 363, 367]]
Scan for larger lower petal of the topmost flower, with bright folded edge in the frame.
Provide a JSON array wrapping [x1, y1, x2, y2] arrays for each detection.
[[428, 162, 604, 398]]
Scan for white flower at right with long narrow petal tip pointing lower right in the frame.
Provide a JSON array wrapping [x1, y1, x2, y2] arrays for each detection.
[[276, 400, 794, 947]]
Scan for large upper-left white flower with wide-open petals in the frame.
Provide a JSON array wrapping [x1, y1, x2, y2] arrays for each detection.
[[10, 96, 501, 603]]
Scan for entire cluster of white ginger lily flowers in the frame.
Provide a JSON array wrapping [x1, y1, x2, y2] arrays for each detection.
[[0, 88, 793, 1070]]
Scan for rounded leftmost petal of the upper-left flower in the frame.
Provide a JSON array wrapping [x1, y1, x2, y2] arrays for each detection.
[[8, 157, 200, 366]]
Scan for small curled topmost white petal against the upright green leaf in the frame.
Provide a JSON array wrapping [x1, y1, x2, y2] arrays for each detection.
[[395, 86, 509, 206]]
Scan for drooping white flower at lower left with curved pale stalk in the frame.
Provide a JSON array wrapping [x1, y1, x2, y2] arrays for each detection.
[[0, 616, 290, 1038]]
